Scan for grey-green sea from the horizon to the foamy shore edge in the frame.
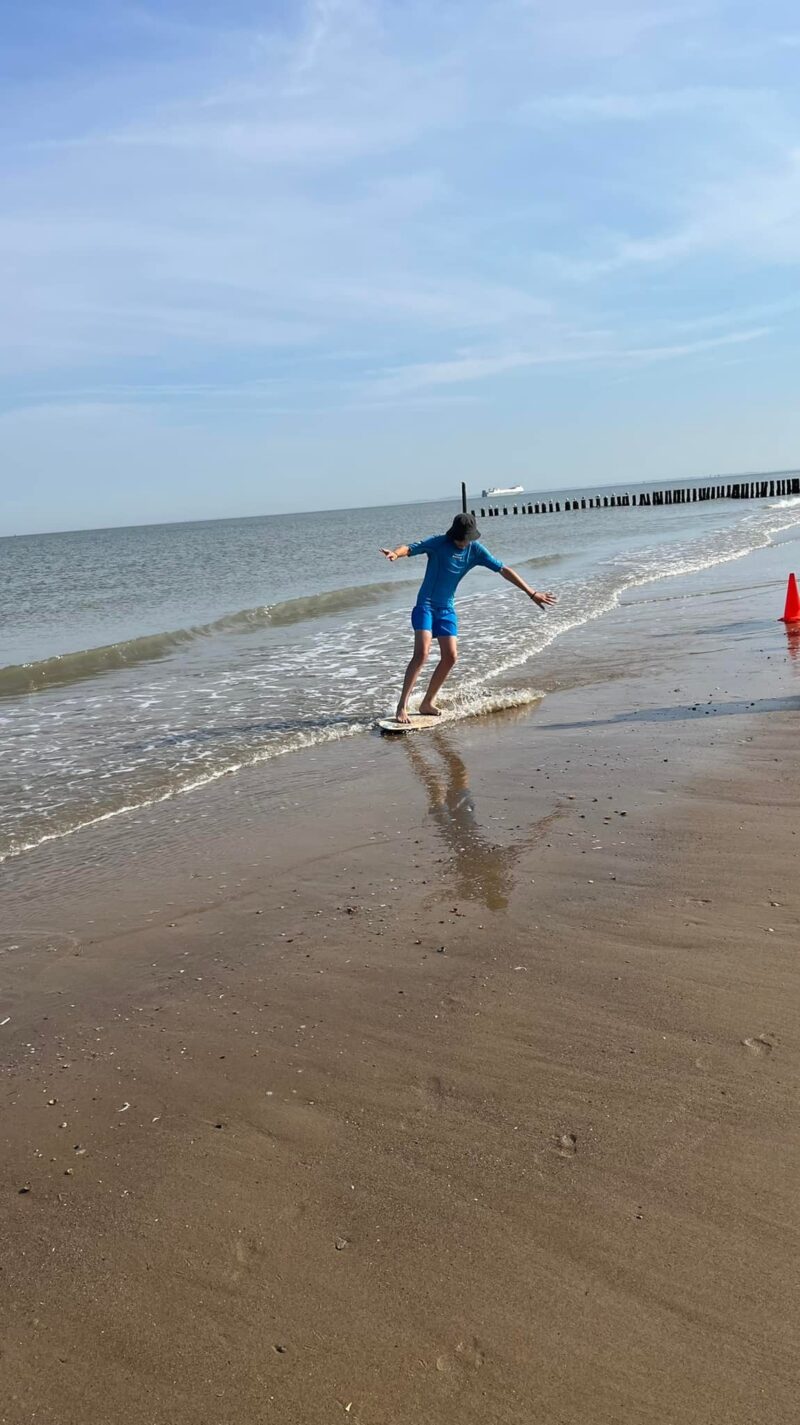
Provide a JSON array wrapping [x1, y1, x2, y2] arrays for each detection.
[[0, 486, 800, 859]]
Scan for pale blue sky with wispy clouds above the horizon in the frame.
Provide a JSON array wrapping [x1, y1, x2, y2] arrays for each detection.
[[0, 0, 800, 533]]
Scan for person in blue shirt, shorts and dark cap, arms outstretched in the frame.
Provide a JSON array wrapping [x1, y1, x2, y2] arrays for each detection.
[[381, 514, 556, 722]]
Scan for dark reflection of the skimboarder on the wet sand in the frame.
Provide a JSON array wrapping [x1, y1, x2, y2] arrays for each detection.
[[405, 730, 528, 911]]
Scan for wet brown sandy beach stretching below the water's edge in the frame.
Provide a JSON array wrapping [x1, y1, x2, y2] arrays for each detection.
[[0, 538, 800, 1425]]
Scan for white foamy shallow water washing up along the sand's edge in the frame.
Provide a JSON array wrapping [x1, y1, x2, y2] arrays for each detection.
[[9, 497, 800, 859]]
